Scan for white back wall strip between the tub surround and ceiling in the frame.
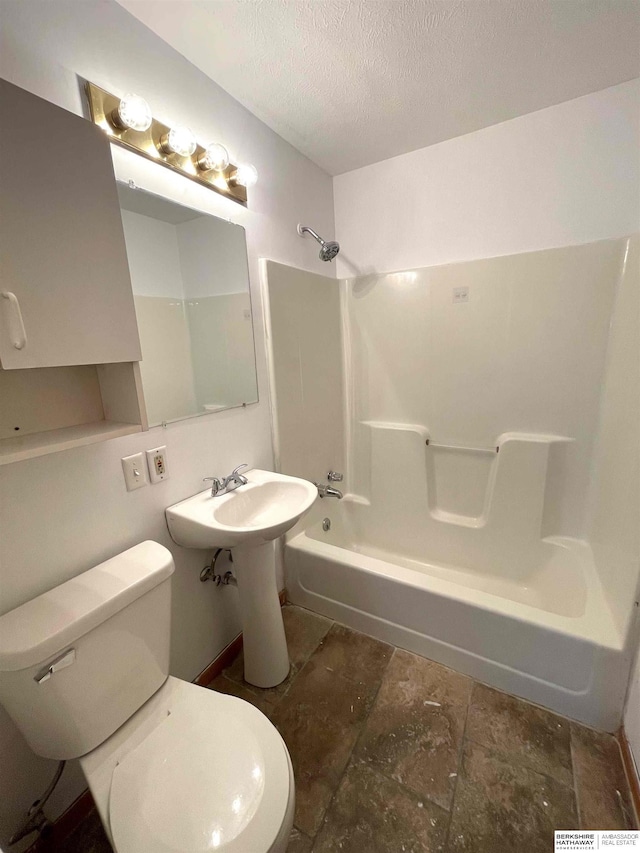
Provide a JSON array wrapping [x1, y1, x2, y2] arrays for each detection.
[[334, 80, 640, 277]]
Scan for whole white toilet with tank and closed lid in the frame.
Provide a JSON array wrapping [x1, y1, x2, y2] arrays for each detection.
[[0, 541, 295, 853]]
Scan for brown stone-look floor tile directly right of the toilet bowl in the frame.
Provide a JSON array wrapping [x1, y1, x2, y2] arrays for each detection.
[[271, 702, 359, 835]]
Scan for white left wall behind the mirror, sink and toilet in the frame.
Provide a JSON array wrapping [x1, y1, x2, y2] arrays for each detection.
[[0, 0, 333, 853]]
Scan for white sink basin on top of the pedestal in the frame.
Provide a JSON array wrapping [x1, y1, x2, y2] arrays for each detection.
[[165, 468, 318, 548]]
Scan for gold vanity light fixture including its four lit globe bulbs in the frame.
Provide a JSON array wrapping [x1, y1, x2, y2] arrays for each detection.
[[86, 82, 258, 207]]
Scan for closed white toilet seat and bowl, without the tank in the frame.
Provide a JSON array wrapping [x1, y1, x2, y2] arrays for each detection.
[[81, 679, 292, 853]]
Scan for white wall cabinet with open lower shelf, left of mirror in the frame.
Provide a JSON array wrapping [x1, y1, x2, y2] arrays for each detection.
[[0, 80, 146, 464]]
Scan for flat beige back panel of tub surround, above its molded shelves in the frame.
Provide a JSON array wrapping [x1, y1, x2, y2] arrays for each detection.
[[346, 240, 625, 536]]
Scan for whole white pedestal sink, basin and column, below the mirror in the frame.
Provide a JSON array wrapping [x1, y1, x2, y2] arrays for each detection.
[[165, 468, 318, 687]]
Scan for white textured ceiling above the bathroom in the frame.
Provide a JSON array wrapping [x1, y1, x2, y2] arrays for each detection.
[[118, 0, 640, 174]]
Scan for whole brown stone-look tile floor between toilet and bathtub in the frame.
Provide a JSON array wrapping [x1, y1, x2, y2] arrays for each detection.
[[53, 605, 633, 853]]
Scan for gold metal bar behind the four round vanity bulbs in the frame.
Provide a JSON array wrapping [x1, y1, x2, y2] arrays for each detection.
[[86, 82, 247, 207]]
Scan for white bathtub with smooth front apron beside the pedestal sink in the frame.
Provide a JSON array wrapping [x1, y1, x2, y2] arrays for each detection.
[[284, 496, 629, 731]]
